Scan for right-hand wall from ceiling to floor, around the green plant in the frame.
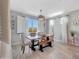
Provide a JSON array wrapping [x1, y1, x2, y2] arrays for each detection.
[[68, 10, 79, 46]]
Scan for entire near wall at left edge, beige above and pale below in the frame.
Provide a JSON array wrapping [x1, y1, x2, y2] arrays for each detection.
[[0, 0, 12, 59]]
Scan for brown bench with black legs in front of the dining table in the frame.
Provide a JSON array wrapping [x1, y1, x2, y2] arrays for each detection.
[[39, 36, 54, 52]]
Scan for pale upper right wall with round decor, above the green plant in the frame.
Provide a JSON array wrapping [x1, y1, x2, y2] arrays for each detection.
[[69, 10, 79, 32]]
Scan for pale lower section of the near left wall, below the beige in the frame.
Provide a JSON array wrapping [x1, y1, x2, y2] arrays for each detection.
[[0, 41, 12, 59]]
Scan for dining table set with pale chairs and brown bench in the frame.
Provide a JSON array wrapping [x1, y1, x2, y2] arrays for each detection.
[[21, 32, 54, 53]]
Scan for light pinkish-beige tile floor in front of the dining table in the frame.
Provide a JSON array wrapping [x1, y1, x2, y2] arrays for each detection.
[[13, 43, 79, 59]]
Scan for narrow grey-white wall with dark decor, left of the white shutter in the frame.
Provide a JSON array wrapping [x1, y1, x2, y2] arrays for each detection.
[[11, 13, 21, 44]]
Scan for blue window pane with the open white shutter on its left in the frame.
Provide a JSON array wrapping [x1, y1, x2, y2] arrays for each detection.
[[17, 16, 38, 33]]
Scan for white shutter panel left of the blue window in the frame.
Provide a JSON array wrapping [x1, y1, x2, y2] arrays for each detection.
[[17, 16, 26, 33]]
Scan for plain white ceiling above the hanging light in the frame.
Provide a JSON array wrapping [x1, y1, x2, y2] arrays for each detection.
[[11, 0, 79, 16]]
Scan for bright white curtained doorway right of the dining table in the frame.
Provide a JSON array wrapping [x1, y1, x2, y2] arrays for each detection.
[[49, 17, 68, 43]]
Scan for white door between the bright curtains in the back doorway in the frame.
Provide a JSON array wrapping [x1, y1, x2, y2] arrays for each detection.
[[54, 19, 62, 41]]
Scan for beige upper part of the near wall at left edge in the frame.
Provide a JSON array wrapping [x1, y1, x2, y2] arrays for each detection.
[[0, 0, 11, 43]]
